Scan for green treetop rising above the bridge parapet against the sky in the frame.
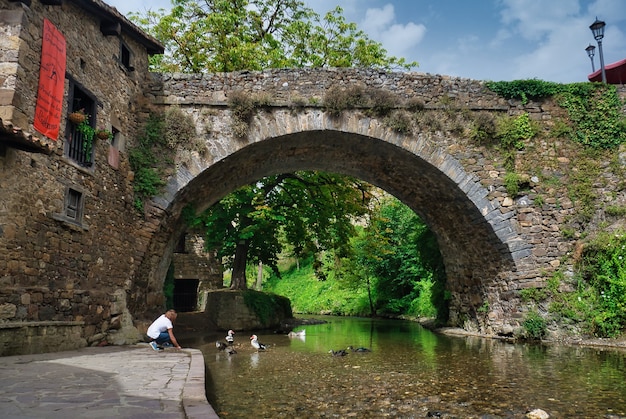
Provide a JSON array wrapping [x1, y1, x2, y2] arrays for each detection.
[[130, 0, 417, 73]]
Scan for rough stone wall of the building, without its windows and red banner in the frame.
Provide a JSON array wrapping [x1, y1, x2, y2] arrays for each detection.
[[0, 0, 163, 354]]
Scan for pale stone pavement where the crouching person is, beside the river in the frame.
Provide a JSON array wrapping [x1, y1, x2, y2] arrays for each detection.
[[0, 343, 218, 419]]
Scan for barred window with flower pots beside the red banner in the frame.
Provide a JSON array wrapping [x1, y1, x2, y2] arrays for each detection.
[[64, 80, 96, 167]]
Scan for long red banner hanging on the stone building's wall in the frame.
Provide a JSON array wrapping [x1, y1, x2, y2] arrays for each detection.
[[33, 19, 65, 141]]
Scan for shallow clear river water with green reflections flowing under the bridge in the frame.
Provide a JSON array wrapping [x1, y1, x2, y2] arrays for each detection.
[[179, 316, 626, 419]]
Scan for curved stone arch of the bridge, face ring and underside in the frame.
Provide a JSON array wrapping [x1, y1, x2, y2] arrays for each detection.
[[135, 109, 532, 332]]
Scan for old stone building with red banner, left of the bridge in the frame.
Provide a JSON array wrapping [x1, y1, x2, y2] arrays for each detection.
[[0, 0, 219, 355]]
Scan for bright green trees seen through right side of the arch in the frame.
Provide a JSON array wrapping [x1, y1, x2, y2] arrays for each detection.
[[342, 197, 447, 320]]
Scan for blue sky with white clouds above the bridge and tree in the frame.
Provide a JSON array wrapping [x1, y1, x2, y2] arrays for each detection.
[[104, 0, 626, 83]]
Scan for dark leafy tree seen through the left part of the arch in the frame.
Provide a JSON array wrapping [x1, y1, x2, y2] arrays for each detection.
[[185, 172, 370, 289]]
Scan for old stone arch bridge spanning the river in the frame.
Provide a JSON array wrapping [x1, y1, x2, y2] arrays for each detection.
[[131, 69, 604, 334]]
